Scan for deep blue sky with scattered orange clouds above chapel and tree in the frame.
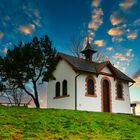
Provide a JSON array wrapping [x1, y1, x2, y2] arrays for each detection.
[[0, 0, 140, 101]]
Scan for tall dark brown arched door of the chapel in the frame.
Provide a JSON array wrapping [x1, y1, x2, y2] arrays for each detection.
[[102, 80, 110, 112]]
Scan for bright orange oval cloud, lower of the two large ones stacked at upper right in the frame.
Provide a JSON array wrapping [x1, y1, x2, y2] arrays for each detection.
[[108, 27, 124, 36]]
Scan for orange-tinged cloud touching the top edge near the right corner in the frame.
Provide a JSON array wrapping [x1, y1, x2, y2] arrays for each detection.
[[119, 0, 136, 10]]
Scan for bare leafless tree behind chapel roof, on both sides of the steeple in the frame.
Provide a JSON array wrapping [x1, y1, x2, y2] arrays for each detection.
[[68, 36, 108, 62]]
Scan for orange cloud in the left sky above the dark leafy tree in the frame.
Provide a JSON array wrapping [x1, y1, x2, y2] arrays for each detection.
[[19, 24, 35, 35]]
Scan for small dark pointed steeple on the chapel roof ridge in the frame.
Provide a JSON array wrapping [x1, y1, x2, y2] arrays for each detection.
[[81, 37, 97, 61]]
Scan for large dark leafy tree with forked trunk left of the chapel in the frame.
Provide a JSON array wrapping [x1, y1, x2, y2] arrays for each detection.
[[0, 36, 57, 108]]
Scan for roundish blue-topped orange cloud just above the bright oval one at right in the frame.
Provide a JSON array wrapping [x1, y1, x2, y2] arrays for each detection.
[[110, 11, 124, 25]]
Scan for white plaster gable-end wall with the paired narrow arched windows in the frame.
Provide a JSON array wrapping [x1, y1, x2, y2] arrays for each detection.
[[47, 60, 76, 109]]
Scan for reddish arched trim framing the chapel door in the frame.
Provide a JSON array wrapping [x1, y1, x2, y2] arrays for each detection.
[[100, 77, 112, 112]]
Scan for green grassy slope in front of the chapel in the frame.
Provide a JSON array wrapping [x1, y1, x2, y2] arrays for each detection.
[[0, 106, 140, 140]]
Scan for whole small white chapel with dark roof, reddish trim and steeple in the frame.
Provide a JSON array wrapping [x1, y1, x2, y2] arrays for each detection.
[[46, 39, 135, 113]]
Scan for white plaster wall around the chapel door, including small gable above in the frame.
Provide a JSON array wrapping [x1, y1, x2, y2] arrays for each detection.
[[77, 67, 131, 113]]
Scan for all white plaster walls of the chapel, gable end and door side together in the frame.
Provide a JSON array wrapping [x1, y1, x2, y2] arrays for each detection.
[[47, 60, 130, 113]]
